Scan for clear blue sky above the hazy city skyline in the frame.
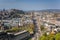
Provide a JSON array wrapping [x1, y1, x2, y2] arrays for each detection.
[[0, 0, 60, 11]]
